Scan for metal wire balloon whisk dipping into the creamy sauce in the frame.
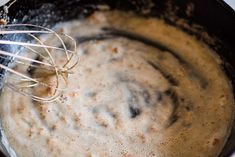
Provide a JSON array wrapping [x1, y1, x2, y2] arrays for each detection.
[[0, 24, 78, 102]]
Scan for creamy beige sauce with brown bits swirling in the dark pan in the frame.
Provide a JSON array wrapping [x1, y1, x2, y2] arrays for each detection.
[[0, 12, 233, 157]]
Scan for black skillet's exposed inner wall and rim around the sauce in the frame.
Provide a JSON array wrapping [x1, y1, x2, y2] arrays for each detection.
[[0, 0, 235, 157]]
